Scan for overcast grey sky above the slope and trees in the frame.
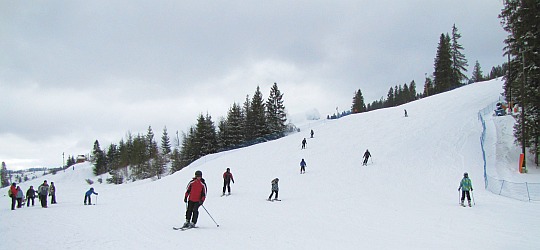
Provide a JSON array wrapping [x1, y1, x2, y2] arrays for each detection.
[[0, 0, 506, 169]]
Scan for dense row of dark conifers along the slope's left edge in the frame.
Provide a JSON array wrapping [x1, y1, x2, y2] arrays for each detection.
[[91, 83, 288, 184]]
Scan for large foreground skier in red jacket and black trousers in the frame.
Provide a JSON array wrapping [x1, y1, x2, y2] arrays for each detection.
[[182, 170, 206, 228]]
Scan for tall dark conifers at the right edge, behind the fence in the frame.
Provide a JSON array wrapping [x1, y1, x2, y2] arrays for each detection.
[[499, 0, 540, 166]]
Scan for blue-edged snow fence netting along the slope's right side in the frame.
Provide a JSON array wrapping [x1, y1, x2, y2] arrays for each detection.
[[478, 100, 540, 201]]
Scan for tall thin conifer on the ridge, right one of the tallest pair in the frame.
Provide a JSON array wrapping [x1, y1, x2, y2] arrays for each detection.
[[450, 24, 468, 88]]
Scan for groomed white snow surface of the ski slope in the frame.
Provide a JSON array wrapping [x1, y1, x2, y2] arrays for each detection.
[[0, 80, 540, 250]]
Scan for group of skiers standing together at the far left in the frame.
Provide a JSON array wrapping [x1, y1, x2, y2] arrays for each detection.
[[8, 180, 56, 210]]
